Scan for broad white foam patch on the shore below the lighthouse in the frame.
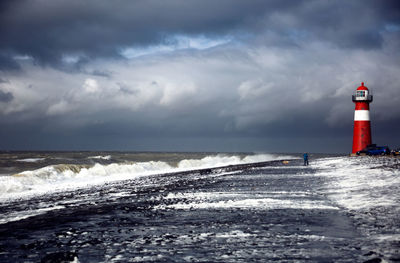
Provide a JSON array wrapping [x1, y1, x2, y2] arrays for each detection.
[[313, 157, 400, 210]]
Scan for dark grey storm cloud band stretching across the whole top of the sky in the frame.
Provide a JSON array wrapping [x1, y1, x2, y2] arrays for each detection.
[[0, 0, 399, 68]]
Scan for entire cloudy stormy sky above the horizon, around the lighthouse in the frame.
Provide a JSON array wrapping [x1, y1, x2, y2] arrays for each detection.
[[0, 0, 400, 153]]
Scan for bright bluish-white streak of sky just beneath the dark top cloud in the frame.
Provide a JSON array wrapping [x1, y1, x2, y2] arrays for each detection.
[[120, 35, 232, 58]]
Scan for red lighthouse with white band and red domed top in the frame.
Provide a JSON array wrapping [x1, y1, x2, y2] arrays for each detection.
[[352, 82, 372, 153]]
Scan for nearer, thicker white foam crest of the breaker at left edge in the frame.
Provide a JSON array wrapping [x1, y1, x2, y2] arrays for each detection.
[[0, 162, 172, 198]]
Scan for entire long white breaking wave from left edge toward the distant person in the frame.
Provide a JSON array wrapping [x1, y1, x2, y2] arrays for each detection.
[[0, 154, 294, 199]]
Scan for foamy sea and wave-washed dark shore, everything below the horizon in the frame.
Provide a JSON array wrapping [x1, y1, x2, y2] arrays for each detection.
[[0, 152, 400, 263]]
